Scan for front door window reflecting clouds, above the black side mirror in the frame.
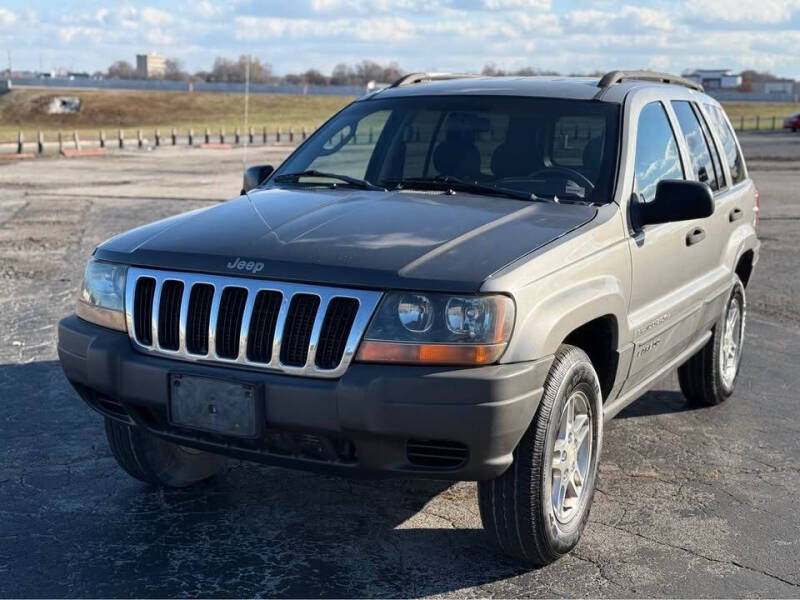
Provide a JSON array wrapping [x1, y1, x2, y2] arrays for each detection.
[[636, 102, 684, 202]]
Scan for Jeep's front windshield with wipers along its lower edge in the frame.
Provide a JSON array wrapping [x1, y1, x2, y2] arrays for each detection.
[[269, 95, 619, 203]]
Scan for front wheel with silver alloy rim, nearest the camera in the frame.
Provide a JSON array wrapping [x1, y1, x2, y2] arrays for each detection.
[[478, 345, 603, 567]]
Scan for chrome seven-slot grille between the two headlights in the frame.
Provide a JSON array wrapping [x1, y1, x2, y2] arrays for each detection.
[[125, 268, 381, 377]]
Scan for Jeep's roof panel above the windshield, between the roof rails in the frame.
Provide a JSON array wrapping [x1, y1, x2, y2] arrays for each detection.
[[364, 76, 708, 104]]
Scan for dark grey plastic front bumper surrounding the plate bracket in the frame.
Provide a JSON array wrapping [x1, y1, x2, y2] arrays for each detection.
[[58, 315, 552, 480]]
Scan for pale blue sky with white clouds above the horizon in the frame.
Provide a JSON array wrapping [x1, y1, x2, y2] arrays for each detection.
[[0, 0, 800, 78]]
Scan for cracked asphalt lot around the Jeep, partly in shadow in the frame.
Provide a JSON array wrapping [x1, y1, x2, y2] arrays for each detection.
[[0, 134, 800, 597]]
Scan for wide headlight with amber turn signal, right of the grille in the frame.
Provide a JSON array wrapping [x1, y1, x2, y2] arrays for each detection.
[[356, 292, 514, 365]]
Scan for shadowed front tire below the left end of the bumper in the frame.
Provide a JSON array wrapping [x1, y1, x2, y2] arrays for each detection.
[[105, 418, 226, 488]]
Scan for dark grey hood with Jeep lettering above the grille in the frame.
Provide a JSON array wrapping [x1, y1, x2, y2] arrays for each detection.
[[96, 189, 597, 292]]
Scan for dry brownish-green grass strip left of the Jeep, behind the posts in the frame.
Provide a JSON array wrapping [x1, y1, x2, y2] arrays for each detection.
[[0, 89, 353, 142]]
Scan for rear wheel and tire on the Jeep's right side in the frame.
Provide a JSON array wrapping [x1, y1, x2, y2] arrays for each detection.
[[678, 277, 747, 406]]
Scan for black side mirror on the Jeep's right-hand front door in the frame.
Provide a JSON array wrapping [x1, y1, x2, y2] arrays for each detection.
[[635, 179, 714, 227]]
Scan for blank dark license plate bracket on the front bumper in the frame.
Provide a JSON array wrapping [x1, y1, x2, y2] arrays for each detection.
[[169, 373, 259, 438]]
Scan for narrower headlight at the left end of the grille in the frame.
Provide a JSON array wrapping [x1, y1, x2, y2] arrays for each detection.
[[75, 259, 128, 331]]
